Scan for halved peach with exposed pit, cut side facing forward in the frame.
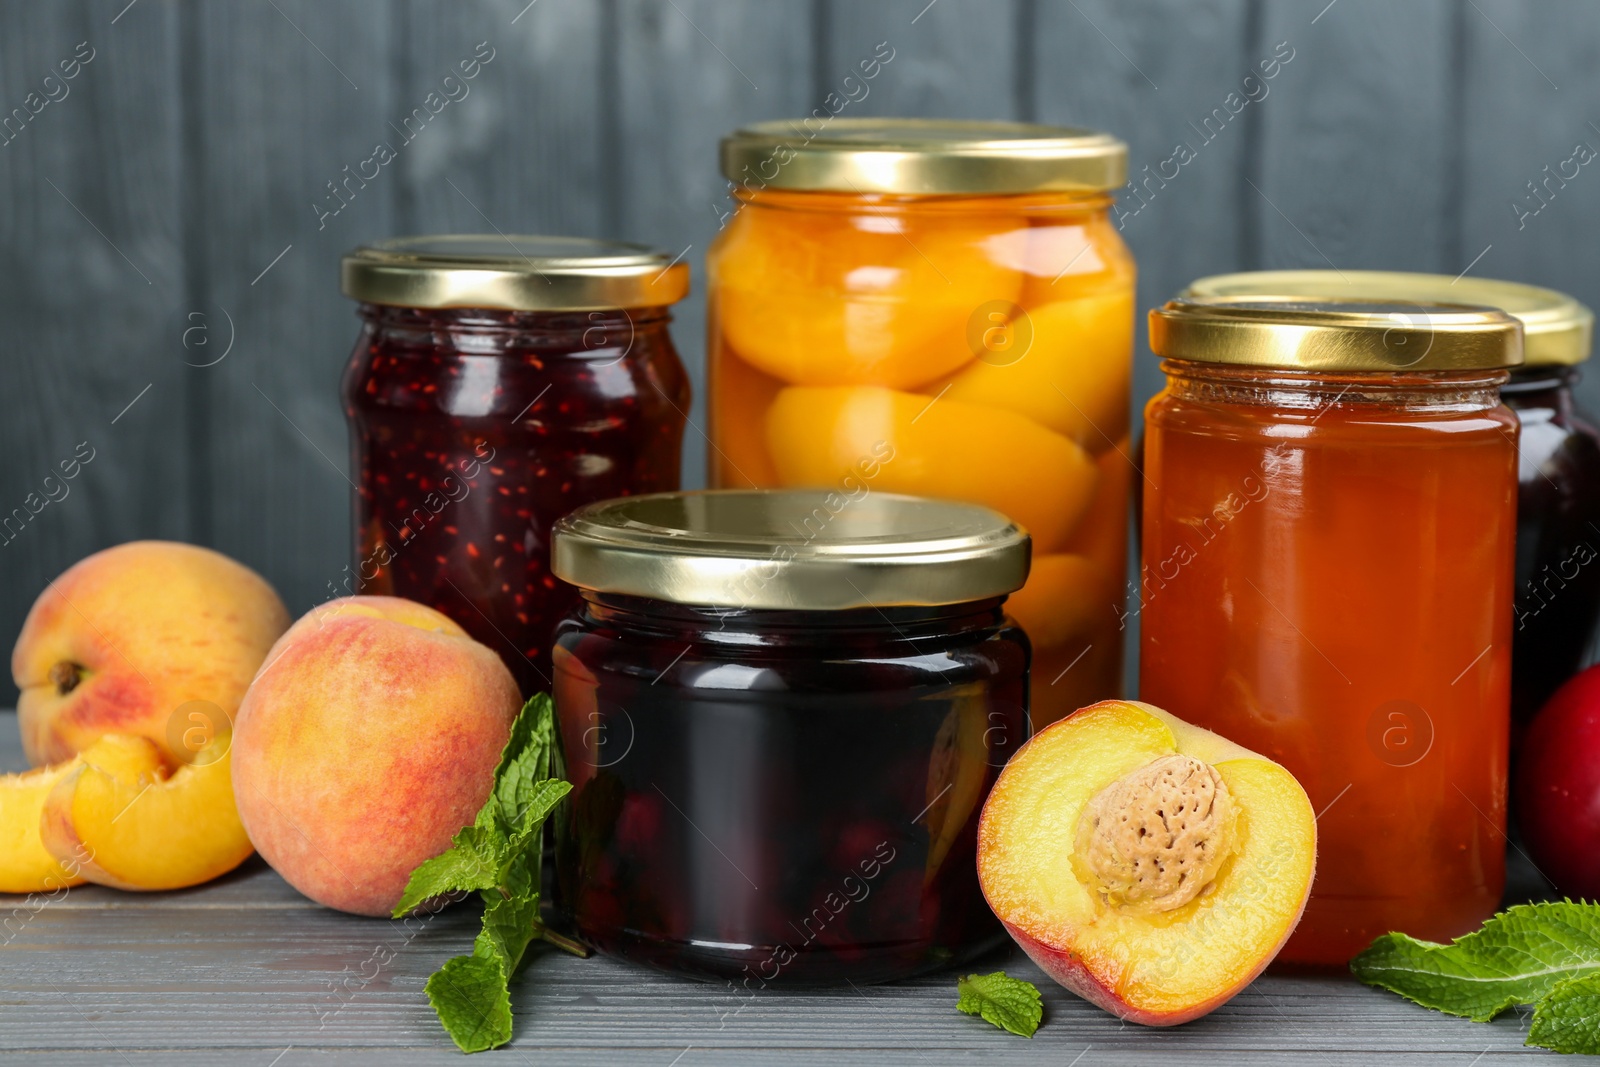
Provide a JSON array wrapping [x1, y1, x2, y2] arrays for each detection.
[[978, 701, 1317, 1025]]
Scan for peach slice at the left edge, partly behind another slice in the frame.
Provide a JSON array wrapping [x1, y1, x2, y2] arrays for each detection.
[[0, 734, 162, 893]]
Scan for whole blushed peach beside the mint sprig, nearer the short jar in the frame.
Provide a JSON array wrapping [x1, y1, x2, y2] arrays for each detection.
[[232, 597, 522, 915]]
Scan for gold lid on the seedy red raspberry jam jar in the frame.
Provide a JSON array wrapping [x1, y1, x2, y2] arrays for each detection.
[[339, 234, 690, 312]]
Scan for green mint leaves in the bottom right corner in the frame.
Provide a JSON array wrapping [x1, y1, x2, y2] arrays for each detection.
[[1350, 901, 1600, 1053]]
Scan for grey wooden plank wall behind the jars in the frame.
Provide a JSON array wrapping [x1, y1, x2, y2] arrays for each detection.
[[0, 0, 1600, 710]]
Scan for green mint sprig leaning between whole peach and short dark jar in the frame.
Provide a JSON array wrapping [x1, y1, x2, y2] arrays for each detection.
[[394, 693, 589, 1053]]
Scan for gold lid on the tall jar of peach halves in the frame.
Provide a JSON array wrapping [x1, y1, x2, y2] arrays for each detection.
[[722, 118, 1128, 195]]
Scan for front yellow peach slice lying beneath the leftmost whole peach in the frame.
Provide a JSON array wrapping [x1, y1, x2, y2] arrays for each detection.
[[40, 733, 254, 889]]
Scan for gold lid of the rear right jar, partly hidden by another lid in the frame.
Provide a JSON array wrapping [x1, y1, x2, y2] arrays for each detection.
[[1182, 270, 1595, 366]]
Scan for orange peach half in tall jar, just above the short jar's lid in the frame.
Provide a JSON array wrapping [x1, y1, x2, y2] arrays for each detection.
[[766, 386, 1099, 552]]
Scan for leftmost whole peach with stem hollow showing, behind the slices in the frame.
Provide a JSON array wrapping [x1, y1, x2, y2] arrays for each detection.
[[11, 541, 290, 765]]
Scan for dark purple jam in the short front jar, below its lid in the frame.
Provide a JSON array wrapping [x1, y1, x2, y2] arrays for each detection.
[[555, 592, 1029, 995]]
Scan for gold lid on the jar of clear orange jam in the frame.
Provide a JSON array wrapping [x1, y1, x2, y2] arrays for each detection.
[[1150, 294, 1522, 373]]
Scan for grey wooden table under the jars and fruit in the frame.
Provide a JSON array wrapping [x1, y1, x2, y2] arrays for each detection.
[[0, 713, 1574, 1067]]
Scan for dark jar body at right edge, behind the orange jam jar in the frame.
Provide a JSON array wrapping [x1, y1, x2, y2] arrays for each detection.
[[1501, 366, 1600, 734]]
